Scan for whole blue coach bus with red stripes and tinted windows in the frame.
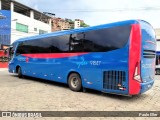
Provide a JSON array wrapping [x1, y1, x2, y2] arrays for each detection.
[[9, 20, 156, 95]]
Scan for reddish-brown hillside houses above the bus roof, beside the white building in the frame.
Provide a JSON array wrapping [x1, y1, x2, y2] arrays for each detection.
[[52, 18, 74, 32]]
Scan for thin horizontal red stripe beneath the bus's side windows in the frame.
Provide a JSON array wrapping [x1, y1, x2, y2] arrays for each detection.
[[22, 53, 87, 58]]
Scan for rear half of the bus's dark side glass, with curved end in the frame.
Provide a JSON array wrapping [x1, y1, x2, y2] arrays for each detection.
[[71, 25, 131, 52]]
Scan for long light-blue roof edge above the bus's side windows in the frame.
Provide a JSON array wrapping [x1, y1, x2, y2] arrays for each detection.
[[14, 20, 139, 43]]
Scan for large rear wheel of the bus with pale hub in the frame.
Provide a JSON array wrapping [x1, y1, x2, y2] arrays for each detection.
[[68, 73, 82, 92]]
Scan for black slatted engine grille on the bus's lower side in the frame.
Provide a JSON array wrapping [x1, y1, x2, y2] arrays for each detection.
[[103, 71, 126, 90]]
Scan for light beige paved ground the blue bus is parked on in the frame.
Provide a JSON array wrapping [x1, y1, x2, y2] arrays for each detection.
[[0, 69, 160, 119]]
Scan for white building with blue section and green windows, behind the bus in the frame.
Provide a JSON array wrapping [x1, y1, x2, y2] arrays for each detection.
[[0, 0, 51, 45]]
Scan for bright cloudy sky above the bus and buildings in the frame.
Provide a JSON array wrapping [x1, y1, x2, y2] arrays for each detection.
[[16, 0, 160, 28]]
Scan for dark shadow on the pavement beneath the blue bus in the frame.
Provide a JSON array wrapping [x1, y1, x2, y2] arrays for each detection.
[[11, 75, 148, 102]]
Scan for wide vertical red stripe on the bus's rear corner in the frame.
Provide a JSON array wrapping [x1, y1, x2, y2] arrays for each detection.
[[129, 24, 142, 95]]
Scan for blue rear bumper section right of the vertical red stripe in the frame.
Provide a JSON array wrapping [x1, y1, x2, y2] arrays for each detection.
[[140, 80, 154, 94]]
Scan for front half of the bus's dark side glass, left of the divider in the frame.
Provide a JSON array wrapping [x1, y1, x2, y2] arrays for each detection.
[[17, 35, 69, 54]]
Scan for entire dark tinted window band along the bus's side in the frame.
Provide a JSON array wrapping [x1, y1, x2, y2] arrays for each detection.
[[17, 25, 131, 54]]
